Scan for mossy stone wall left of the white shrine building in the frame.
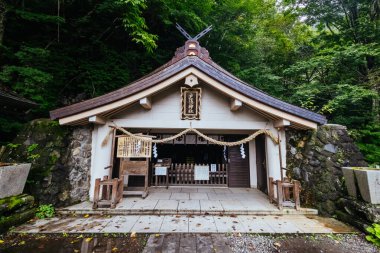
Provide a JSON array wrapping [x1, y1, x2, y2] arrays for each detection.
[[0, 119, 92, 207]]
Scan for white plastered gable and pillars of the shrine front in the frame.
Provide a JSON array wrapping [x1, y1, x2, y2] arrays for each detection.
[[90, 85, 286, 200]]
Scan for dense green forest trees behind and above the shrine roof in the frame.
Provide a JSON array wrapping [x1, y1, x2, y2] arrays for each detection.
[[0, 0, 380, 164]]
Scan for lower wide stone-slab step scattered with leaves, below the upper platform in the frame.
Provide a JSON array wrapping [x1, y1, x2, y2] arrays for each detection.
[[14, 215, 355, 234]]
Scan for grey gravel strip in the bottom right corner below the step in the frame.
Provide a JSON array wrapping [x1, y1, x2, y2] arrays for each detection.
[[228, 234, 380, 253]]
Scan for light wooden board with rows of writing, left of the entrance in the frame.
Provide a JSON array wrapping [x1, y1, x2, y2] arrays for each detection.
[[116, 137, 152, 158]]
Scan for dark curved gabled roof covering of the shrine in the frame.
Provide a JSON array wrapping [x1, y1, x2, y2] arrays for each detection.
[[50, 41, 327, 124]]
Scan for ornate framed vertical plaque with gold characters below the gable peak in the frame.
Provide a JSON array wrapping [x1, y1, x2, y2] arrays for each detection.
[[181, 87, 202, 120]]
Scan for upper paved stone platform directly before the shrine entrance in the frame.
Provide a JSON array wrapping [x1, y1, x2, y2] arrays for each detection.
[[58, 187, 318, 215]]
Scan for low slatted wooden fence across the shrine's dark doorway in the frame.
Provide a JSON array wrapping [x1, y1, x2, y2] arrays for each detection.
[[151, 163, 228, 186]]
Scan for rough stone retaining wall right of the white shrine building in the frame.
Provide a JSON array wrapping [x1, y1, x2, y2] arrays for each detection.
[[287, 124, 367, 215]]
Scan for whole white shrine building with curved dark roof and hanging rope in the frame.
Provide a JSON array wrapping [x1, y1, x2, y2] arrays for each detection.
[[50, 39, 326, 204]]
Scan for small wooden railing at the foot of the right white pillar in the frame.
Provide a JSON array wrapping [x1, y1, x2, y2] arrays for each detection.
[[268, 177, 301, 210]]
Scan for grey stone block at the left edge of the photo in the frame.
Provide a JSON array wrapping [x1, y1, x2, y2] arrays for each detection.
[[0, 163, 31, 199]]
